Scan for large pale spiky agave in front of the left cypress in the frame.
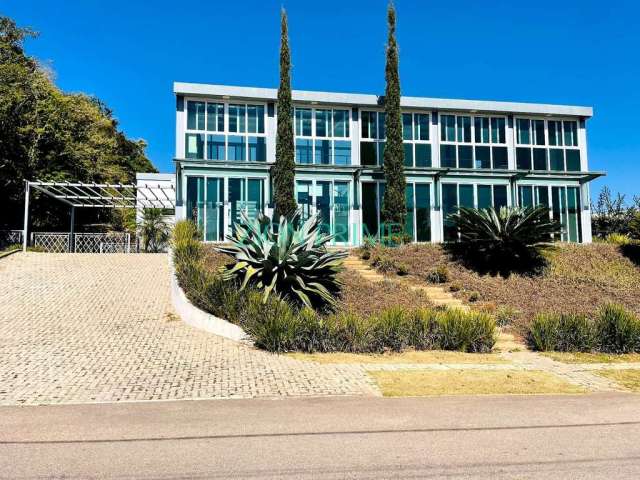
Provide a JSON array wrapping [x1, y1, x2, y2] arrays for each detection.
[[217, 211, 347, 308]]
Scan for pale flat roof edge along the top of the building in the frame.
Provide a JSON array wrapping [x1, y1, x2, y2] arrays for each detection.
[[173, 82, 593, 117]]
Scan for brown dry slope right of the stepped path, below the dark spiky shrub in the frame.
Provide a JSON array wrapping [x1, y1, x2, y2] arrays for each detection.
[[368, 243, 640, 330]]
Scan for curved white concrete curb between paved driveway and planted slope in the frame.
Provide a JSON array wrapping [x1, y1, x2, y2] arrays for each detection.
[[168, 252, 248, 342]]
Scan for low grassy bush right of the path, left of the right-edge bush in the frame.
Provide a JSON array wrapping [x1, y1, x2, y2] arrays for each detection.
[[529, 313, 594, 352]]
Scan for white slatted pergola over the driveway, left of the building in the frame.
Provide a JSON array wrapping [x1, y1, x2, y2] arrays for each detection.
[[22, 181, 176, 251]]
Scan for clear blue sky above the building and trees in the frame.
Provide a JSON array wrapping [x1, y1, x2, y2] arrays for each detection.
[[5, 0, 640, 197]]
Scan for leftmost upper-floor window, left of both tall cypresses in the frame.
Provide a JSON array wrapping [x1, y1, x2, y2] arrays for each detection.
[[185, 100, 267, 162]]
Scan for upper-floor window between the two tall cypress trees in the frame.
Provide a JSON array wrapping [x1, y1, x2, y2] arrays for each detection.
[[294, 107, 351, 165]]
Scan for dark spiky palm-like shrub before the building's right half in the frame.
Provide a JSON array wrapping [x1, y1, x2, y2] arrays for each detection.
[[449, 206, 561, 272]]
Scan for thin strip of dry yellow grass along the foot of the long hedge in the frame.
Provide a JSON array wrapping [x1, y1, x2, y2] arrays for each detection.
[[288, 350, 508, 364]]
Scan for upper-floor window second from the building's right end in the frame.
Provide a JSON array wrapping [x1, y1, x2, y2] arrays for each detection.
[[440, 115, 508, 169]]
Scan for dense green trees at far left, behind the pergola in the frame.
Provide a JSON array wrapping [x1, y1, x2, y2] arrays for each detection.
[[0, 17, 155, 228]]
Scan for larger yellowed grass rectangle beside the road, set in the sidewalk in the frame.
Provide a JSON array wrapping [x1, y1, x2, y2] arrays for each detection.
[[370, 370, 586, 397]]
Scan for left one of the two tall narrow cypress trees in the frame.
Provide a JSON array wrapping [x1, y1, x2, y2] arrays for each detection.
[[273, 9, 298, 217]]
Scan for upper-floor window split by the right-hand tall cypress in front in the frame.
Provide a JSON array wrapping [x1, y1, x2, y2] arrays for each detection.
[[360, 111, 431, 167]]
